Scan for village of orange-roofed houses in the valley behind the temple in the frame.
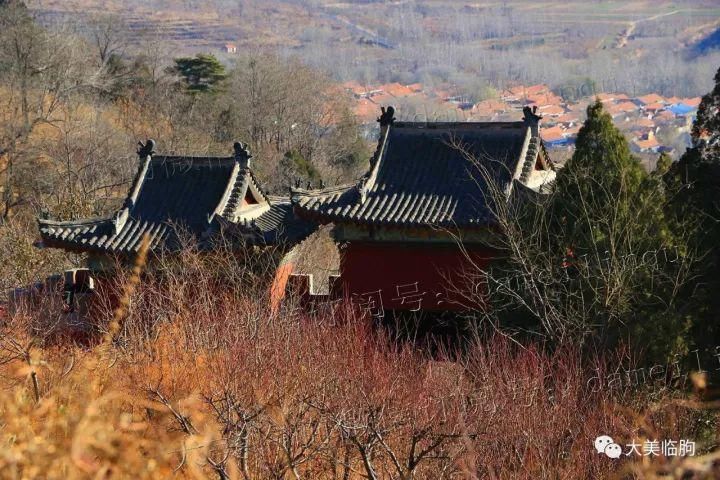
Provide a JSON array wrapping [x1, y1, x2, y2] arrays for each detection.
[[341, 81, 701, 161]]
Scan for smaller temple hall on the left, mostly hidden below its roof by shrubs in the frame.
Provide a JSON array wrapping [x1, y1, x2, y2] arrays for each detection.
[[33, 140, 317, 308]]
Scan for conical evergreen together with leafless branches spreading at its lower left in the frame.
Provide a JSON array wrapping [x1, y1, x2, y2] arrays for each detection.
[[490, 101, 690, 361]]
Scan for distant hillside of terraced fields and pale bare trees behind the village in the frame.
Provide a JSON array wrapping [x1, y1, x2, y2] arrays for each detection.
[[25, 0, 720, 96]]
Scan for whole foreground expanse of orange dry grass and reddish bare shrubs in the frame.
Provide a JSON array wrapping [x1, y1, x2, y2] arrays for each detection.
[[0, 242, 716, 480]]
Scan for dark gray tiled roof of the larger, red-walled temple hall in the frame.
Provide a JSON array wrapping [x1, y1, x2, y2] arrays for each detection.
[[292, 122, 537, 226]]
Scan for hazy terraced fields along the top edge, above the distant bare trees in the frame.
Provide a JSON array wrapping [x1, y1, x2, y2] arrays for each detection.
[[29, 0, 720, 54]]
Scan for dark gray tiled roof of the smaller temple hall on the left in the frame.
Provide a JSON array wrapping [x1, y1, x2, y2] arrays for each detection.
[[38, 156, 311, 253]]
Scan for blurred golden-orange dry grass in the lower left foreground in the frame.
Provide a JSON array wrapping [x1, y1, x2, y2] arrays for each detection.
[[0, 241, 236, 479]]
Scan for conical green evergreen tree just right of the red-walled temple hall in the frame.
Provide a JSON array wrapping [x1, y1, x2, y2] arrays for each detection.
[[547, 101, 687, 361]]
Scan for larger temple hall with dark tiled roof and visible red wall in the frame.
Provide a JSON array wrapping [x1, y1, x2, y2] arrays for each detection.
[[292, 107, 555, 317]]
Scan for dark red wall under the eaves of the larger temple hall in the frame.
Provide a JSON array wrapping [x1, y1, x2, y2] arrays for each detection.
[[341, 242, 494, 313]]
